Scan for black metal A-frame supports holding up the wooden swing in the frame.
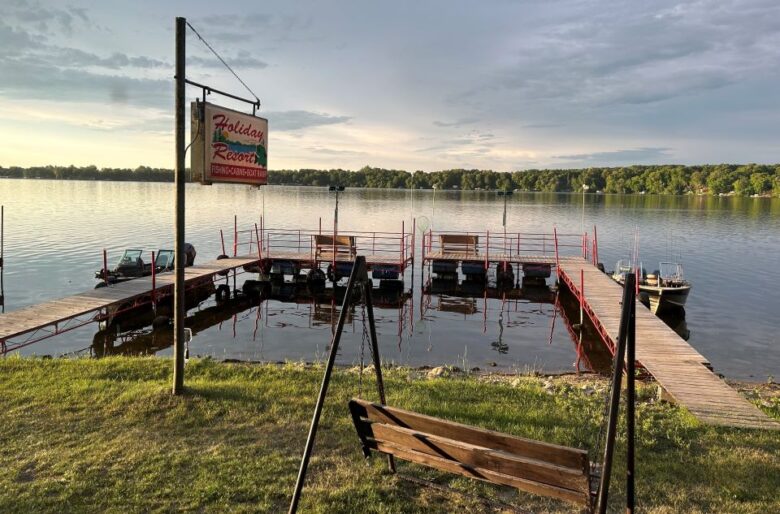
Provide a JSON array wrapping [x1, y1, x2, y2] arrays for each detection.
[[289, 256, 636, 514]]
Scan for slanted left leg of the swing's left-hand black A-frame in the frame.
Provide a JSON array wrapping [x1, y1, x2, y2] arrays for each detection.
[[289, 256, 365, 514]]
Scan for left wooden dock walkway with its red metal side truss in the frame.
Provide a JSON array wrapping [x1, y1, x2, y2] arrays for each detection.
[[0, 257, 258, 353]]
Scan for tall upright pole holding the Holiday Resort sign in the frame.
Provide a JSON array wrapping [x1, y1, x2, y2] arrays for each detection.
[[173, 17, 187, 394]]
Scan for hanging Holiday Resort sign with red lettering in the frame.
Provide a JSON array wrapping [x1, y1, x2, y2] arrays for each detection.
[[191, 102, 268, 185]]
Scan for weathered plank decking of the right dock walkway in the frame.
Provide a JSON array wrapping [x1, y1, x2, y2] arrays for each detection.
[[559, 258, 780, 430]]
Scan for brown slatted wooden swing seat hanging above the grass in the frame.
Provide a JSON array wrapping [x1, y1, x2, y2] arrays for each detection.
[[349, 399, 593, 510]]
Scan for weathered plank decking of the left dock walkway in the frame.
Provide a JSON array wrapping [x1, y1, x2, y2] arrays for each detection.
[[0, 257, 258, 341]]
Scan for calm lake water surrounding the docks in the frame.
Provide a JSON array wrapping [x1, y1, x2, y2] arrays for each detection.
[[0, 179, 780, 380]]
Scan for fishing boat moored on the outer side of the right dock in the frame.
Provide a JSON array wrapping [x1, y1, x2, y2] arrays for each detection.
[[611, 260, 691, 314]]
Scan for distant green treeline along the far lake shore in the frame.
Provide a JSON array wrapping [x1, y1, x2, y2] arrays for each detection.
[[0, 164, 780, 196]]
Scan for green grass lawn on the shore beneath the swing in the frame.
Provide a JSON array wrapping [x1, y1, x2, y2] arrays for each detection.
[[0, 358, 780, 513]]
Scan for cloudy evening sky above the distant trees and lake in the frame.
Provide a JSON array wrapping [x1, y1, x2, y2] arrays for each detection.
[[0, 0, 780, 171]]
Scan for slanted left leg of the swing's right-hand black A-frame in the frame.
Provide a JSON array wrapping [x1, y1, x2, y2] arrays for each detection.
[[596, 273, 636, 514]]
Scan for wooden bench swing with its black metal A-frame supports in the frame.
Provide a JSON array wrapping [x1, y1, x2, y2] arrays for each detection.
[[289, 256, 636, 514]]
